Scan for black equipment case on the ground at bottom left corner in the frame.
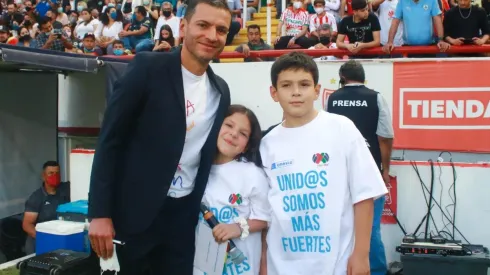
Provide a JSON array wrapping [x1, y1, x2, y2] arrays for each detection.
[[17, 249, 100, 275]]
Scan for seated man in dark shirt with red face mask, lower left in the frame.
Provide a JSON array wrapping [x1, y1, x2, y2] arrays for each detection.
[[22, 160, 70, 255]]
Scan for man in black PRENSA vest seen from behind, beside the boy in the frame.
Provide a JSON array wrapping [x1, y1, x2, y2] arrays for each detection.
[[325, 60, 394, 275]]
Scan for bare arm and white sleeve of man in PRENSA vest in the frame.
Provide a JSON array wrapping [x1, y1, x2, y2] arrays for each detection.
[[376, 93, 394, 176]]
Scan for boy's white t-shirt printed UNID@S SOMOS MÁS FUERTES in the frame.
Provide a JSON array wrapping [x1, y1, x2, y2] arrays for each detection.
[[260, 111, 387, 275]]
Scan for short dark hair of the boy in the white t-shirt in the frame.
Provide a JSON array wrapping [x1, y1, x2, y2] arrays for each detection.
[[271, 52, 318, 88]]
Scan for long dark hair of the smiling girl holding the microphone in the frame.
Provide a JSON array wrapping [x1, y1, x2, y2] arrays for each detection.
[[225, 104, 264, 168]]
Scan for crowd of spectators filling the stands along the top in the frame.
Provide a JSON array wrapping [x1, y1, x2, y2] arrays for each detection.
[[0, 0, 490, 61]]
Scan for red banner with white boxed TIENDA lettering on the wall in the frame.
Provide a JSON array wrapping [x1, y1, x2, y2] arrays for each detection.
[[393, 60, 490, 152]]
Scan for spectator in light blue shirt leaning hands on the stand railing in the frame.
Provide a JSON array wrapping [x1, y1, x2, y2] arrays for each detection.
[[383, 0, 450, 57]]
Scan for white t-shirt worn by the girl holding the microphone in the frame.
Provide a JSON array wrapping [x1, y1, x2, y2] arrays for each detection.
[[194, 161, 271, 275]]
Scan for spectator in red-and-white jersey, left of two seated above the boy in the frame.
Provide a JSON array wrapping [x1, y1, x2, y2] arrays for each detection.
[[274, 0, 310, 49]]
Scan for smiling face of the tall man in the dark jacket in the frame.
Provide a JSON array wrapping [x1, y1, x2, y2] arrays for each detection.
[[179, 4, 231, 64]]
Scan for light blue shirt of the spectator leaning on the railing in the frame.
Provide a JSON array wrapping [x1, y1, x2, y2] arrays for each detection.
[[394, 0, 441, 46]]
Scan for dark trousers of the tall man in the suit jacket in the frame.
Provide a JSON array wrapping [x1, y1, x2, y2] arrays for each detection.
[[116, 194, 198, 275]]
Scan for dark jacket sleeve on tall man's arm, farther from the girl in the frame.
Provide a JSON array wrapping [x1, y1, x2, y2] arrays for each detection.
[[88, 53, 152, 218]]
